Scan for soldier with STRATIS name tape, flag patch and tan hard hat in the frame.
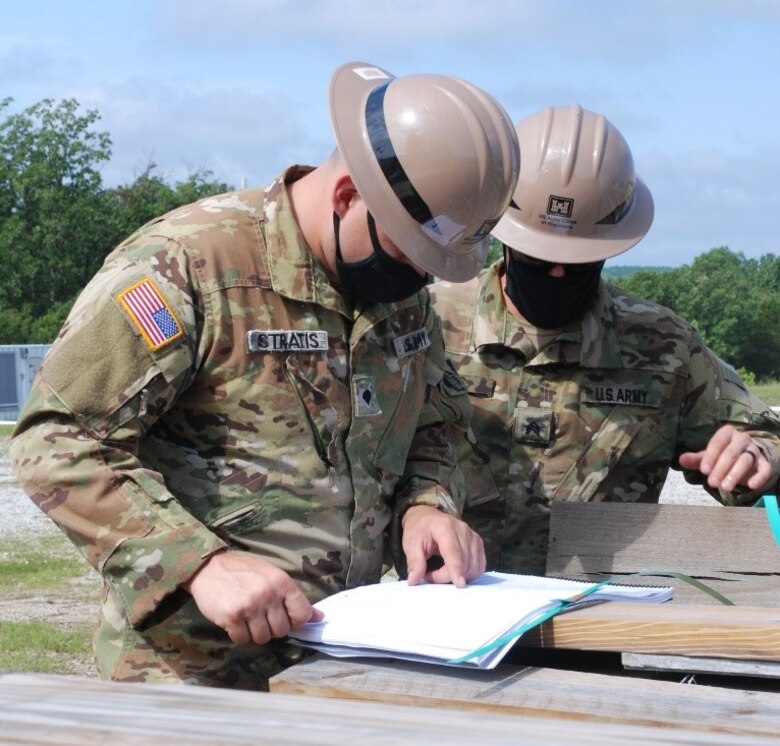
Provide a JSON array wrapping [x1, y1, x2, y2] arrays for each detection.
[[12, 63, 518, 688]]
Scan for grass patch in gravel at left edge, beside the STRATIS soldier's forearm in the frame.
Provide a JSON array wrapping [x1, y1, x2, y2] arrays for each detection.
[[0, 534, 92, 591]]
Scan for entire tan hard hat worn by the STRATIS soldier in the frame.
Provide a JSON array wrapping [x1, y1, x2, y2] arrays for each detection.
[[330, 62, 519, 282]]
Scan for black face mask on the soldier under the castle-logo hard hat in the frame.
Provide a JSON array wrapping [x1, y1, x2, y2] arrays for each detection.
[[504, 249, 604, 329]]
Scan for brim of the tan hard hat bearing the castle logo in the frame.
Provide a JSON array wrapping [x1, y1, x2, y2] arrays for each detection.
[[491, 176, 655, 264]]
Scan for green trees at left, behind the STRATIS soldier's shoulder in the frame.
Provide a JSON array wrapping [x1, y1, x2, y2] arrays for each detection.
[[0, 98, 231, 344]]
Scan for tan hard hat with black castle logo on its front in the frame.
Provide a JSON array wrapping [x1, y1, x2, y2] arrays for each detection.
[[493, 104, 654, 264]]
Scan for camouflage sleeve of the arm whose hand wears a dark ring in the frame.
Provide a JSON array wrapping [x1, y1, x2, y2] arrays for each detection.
[[676, 335, 780, 505]]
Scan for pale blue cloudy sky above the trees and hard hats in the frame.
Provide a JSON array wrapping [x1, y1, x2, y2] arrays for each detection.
[[0, 0, 780, 266]]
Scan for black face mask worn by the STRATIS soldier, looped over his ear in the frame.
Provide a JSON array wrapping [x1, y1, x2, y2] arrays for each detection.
[[333, 212, 428, 303]]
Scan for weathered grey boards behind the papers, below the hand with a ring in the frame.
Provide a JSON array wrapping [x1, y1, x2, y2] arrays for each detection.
[[546, 503, 780, 607]]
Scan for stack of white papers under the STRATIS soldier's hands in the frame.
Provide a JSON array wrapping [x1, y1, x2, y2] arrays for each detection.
[[289, 572, 672, 669]]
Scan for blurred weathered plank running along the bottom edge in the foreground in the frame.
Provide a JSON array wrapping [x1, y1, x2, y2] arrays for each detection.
[[0, 673, 779, 746]]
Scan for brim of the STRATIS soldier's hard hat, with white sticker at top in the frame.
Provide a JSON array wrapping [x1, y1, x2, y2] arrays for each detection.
[[329, 62, 488, 282]]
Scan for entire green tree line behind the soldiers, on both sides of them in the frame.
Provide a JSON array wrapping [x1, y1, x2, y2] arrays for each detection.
[[0, 98, 780, 380]]
